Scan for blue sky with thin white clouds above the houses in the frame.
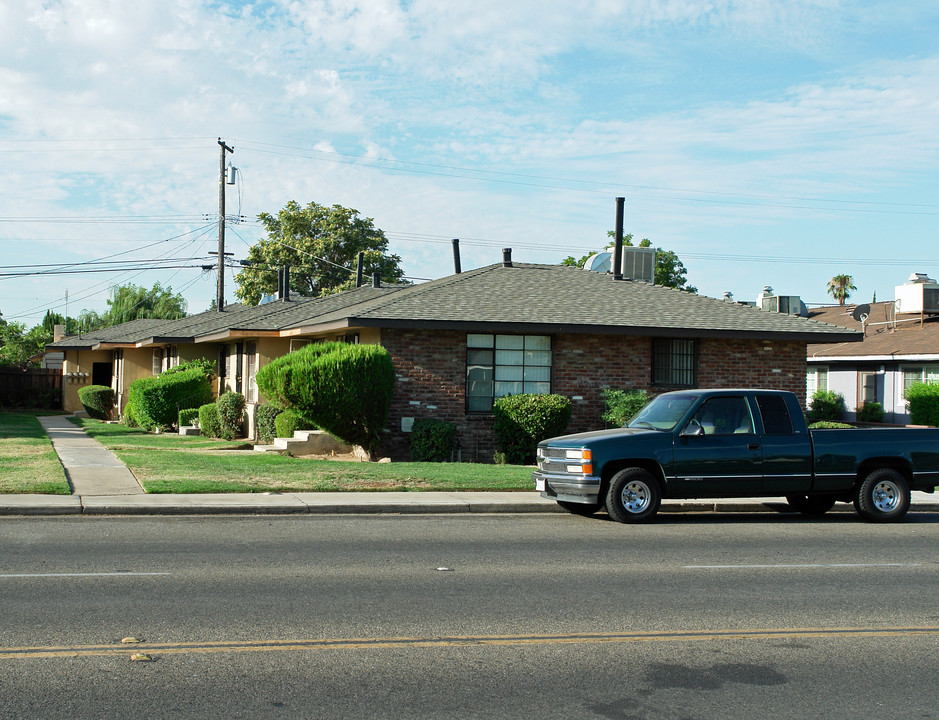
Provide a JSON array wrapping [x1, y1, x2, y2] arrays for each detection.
[[0, 0, 939, 326]]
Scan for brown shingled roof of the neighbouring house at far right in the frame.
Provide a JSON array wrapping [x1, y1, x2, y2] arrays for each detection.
[[809, 302, 939, 360]]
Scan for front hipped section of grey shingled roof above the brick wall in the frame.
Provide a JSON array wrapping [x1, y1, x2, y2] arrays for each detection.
[[286, 263, 861, 342]]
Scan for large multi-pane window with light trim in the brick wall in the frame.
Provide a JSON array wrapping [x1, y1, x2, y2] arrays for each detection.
[[466, 333, 551, 413]]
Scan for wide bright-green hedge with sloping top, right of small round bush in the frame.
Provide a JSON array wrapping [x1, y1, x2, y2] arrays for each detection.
[[127, 368, 212, 430]]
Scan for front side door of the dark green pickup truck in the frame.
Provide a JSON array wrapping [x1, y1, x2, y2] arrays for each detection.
[[670, 396, 763, 497]]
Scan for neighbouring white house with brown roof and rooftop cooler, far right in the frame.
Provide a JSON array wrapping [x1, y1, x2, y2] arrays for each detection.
[[806, 273, 939, 424]]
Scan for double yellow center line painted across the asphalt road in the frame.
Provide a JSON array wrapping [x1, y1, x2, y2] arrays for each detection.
[[0, 627, 939, 660]]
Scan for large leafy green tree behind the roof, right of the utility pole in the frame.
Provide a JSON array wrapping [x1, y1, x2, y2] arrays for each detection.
[[235, 200, 404, 305]]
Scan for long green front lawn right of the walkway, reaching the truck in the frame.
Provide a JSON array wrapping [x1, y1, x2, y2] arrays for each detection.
[[75, 419, 533, 493]]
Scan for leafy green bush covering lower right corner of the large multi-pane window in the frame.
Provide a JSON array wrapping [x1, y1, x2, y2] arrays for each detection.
[[492, 395, 571, 465]]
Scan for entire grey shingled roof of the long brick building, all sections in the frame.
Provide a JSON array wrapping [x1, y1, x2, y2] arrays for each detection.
[[48, 263, 863, 349]]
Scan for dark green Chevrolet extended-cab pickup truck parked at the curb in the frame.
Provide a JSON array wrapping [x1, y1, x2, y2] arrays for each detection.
[[532, 390, 939, 522]]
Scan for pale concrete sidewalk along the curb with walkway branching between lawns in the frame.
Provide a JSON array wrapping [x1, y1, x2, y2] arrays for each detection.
[[0, 416, 939, 515]]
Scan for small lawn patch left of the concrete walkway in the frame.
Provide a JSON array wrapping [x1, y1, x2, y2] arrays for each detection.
[[0, 412, 72, 495]]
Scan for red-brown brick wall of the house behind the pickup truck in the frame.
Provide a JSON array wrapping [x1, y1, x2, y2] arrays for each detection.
[[380, 329, 806, 462]]
